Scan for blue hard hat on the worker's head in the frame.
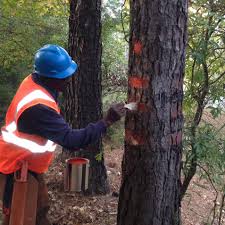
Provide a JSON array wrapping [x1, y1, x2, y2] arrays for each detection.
[[34, 44, 77, 79]]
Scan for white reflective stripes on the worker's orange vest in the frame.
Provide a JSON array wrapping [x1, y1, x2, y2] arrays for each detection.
[[2, 90, 56, 153]]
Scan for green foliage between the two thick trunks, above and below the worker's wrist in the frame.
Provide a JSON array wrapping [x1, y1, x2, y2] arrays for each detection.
[[101, 0, 129, 151]]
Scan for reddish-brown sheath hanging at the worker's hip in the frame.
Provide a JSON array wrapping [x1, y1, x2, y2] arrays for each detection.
[[0, 161, 38, 225]]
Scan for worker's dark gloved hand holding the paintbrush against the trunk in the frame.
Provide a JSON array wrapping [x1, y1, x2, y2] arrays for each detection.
[[103, 103, 126, 126]]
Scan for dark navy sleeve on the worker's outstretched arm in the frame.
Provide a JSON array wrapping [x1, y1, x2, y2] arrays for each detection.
[[18, 104, 106, 149]]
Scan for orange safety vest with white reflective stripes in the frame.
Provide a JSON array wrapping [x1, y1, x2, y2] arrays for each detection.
[[0, 75, 60, 174]]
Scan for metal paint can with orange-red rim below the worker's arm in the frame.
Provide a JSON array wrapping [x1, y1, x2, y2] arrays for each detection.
[[64, 157, 89, 192]]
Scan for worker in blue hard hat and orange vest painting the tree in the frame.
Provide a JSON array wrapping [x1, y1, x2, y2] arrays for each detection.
[[0, 44, 125, 225]]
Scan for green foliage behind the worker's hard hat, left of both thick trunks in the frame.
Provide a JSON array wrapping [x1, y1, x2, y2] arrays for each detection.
[[0, 0, 68, 123]]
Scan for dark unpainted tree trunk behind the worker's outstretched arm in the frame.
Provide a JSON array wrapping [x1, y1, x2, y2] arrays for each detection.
[[65, 0, 109, 194]]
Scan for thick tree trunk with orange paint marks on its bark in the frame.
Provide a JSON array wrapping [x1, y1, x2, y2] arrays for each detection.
[[117, 0, 187, 225]]
